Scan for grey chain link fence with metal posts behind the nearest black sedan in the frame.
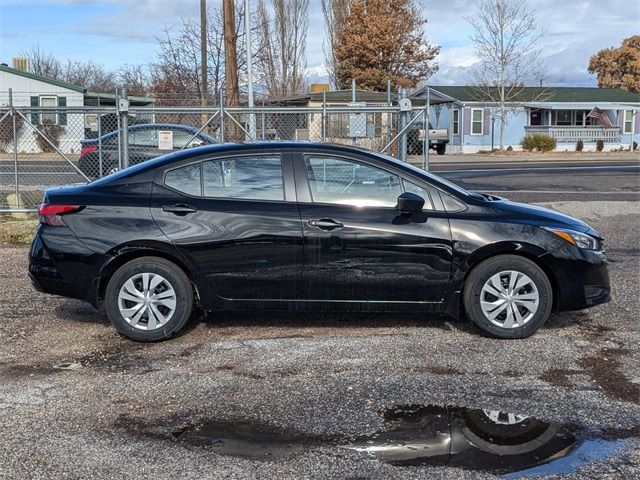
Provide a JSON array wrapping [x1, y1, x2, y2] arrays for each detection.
[[0, 88, 428, 212]]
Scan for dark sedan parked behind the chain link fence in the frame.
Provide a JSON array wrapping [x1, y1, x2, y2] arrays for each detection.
[[78, 123, 216, 178]]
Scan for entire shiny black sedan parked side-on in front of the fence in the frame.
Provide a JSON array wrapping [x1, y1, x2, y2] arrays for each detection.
[[29, 142, 609, 341]]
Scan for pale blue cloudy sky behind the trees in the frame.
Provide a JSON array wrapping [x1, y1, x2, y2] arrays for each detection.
[[0, 0, 640, 85]]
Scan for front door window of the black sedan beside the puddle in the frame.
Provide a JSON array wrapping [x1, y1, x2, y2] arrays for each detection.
[[305, 157, 401, 207]]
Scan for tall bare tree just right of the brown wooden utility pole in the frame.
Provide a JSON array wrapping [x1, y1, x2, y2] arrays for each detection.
[[256, 0, 309, 97]]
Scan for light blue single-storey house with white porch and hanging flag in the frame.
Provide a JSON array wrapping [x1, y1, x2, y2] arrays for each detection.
[[412, 86, 640, 153]]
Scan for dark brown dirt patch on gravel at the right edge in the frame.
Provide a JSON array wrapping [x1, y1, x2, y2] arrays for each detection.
[[578, 348, 640, 403]]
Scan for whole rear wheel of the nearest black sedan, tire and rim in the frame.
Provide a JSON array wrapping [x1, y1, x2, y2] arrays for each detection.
[[104, 257, 193, 342]]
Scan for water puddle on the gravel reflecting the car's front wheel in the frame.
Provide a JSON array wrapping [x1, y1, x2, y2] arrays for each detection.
[[178, 405, 625, 476]]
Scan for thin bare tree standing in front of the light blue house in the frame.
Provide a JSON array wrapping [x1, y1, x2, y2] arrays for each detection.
[[465, 0, 548, 150]]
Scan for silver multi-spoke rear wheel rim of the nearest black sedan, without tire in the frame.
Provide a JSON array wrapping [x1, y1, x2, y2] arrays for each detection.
[[118, 273, 176, 331]]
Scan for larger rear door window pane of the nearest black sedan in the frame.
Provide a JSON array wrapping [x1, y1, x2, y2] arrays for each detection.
[[202, 156, 284, 200]]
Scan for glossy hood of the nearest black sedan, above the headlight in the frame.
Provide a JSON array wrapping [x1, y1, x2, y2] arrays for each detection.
[[487, 197, 601, 238]]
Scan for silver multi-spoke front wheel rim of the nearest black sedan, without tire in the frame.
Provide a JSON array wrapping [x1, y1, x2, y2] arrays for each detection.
[[480, 270, 540, 328]]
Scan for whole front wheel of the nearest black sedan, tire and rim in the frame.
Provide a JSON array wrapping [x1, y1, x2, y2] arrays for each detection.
[[463, 255, 553, 338]]
